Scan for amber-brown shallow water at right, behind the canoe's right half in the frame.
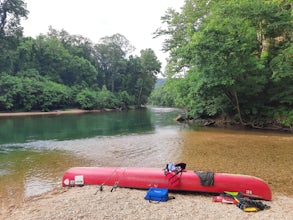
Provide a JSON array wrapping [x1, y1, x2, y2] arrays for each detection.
[[176, 129, 293, 195]]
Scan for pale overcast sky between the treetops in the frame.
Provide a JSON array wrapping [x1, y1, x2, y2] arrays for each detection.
[[21, 0, 184, 72]]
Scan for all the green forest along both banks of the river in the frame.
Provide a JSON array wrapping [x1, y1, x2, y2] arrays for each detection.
[[0, 0, 293, 130]]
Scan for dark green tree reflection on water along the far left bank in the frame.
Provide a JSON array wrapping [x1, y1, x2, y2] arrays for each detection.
[[0, 111, 154, 144]]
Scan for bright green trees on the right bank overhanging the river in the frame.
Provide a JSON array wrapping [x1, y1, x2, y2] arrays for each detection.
[[150, 0, 293, 130]]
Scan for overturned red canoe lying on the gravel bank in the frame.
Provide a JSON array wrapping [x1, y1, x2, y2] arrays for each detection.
[[62, 167, 272, 200]]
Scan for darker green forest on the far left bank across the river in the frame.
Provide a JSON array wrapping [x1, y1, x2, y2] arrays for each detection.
[[0, 0, 161, 112]]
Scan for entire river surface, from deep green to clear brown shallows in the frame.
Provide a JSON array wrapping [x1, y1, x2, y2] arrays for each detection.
[[0, 107, 293, 206]]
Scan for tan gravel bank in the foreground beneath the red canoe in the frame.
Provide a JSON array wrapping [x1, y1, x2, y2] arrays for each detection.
[[0, 186, 293, 220]]
